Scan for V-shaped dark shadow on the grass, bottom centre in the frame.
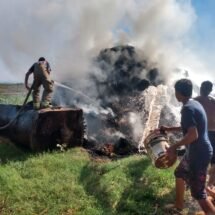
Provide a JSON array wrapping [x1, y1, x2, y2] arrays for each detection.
[[80, 155, 155, 214]]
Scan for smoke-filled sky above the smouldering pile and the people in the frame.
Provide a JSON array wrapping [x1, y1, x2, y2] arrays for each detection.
[[0, 0, 215, 85]]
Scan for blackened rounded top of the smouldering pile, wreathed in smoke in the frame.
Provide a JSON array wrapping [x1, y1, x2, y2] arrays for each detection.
[[90, 46, 164, 101]]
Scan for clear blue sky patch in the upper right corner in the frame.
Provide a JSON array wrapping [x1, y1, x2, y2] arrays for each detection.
[[192, 0, 215, 52]]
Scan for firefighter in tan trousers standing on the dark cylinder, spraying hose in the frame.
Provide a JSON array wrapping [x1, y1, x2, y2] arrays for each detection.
[[25, 57, 54, 110]]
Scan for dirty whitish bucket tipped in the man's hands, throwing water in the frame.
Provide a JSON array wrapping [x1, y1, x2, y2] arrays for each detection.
[[144, 132, 177, 169]]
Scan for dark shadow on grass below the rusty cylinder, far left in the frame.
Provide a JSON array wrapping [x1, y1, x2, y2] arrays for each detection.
[[0, 139, 32, 164]]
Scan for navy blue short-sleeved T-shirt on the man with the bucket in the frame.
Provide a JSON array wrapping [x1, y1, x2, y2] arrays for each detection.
[[181, 99, 213, 169]]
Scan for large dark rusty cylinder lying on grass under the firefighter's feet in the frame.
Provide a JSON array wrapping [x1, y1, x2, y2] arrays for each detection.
[[0, 104, 84, 151]]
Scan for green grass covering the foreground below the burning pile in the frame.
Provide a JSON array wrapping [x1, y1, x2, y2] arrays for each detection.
[[0, 85, 174, 215]]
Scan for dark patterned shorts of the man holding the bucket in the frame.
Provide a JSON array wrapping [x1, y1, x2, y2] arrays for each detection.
[[175, 156, 207, 200]]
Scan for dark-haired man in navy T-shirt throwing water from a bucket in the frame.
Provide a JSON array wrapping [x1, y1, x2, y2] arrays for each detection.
[[161, 79, 215, 214]]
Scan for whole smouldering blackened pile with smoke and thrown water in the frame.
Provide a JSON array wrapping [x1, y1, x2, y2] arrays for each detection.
[[54, 45, 178, 156]]
